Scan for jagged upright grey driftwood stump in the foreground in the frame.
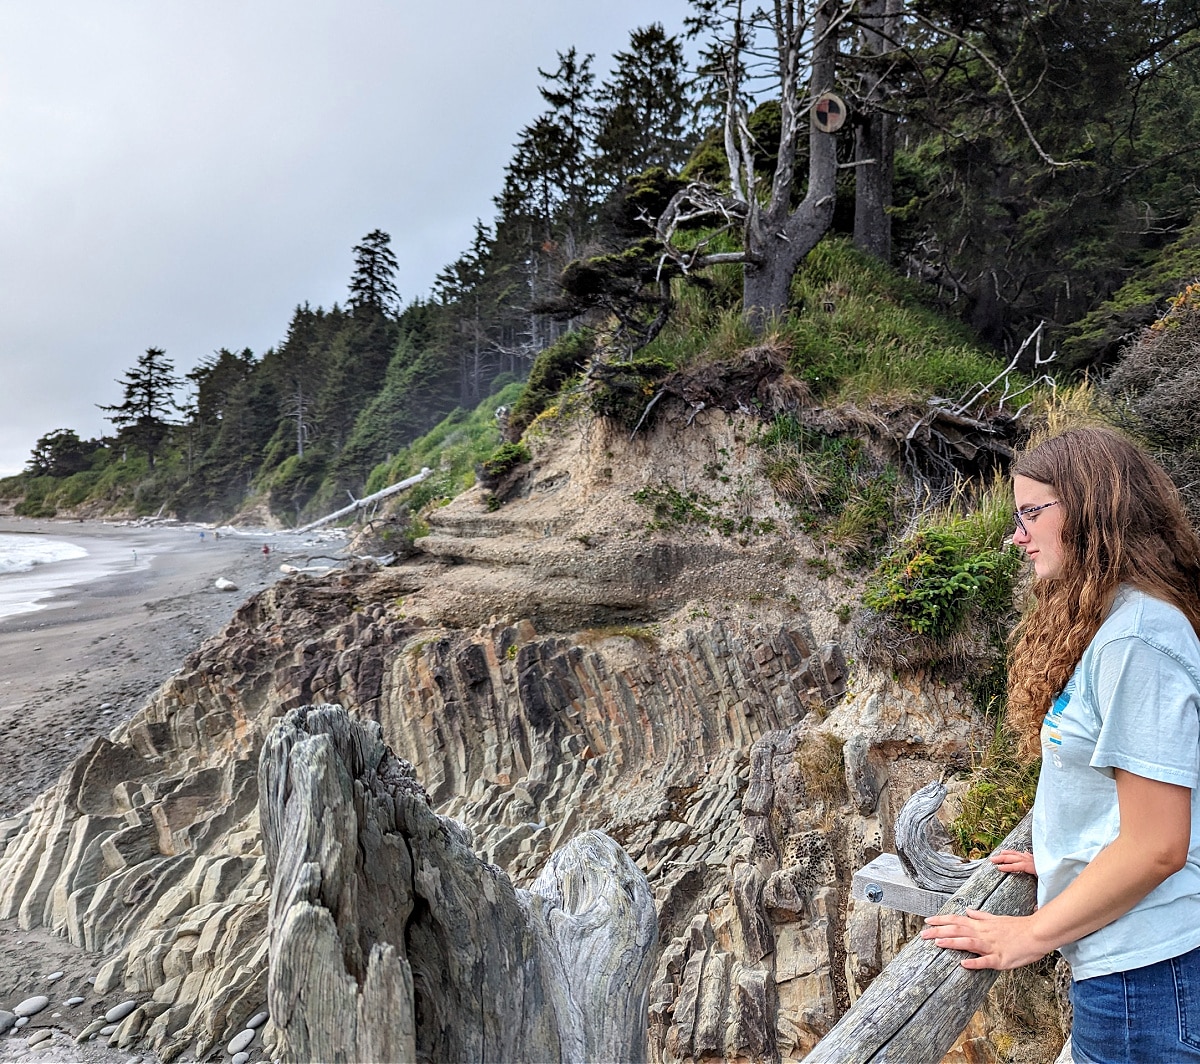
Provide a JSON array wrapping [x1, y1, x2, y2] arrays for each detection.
[[259, 707, 658, 1062]]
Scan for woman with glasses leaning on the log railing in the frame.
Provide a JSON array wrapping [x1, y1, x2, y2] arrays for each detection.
[[922, 428, 1200, 1064]]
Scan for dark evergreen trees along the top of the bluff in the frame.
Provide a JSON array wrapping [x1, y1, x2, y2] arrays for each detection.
[[10, 0, 1200, 521]]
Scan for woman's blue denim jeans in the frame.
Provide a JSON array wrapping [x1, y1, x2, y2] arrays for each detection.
[[1070, 948, 1200, 1064]]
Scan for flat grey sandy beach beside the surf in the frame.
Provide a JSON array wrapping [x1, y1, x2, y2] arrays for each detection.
[[0, 518, 342, 819]]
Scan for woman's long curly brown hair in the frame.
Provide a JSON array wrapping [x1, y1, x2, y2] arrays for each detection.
[[1008, 428, 1200, 759]]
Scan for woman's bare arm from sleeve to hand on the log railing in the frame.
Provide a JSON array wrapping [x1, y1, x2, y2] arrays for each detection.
[[920, 769, 1192, 968]]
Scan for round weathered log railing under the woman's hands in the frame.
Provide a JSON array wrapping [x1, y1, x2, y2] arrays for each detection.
[[805, 816, 1037, 1064]]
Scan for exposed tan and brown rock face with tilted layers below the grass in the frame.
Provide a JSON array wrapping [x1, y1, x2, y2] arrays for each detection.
[[0, 415, 977, 1059]]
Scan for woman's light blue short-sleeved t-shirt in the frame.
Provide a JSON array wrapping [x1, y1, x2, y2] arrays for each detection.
[[1033, 587, 1200, 979]]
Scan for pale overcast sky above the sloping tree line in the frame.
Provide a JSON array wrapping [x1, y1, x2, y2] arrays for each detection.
[[0, 0, 689, 475]]
